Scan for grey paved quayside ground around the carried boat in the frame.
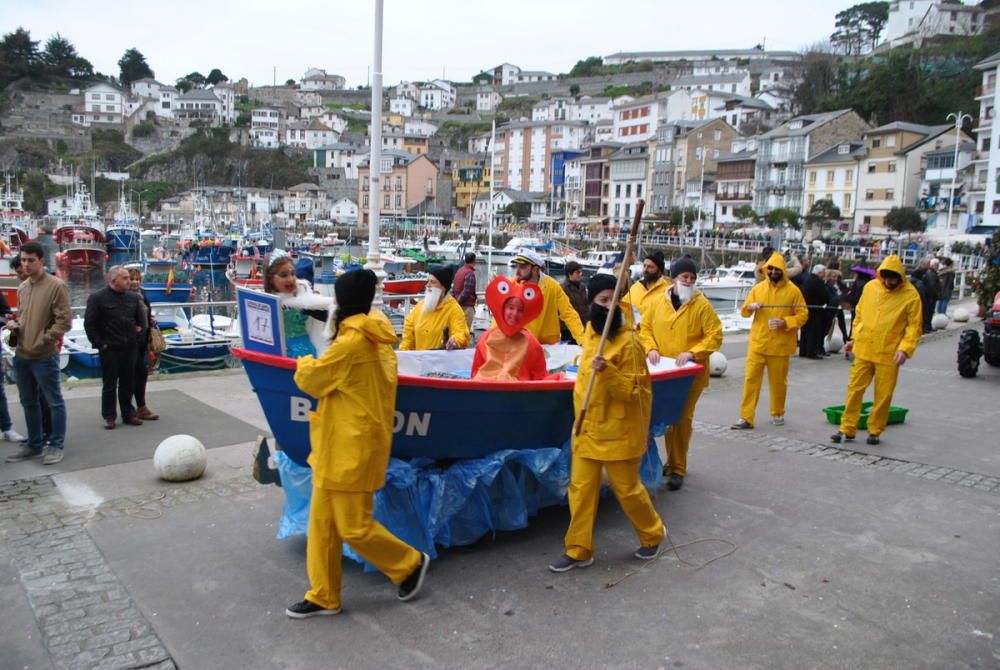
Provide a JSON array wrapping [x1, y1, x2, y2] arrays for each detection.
[[0, 308, 1000, 669]]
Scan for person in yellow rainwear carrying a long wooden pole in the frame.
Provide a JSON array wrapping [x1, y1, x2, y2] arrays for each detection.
[[549, 274, 667, 572]]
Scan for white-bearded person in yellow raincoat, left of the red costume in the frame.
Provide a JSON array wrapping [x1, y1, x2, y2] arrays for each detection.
[[399, 266, 471, 351]]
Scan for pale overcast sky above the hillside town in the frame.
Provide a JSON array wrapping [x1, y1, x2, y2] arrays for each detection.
[[0, 0, 855, 87]]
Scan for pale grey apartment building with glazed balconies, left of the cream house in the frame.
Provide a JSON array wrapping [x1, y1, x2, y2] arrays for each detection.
[[753, 109, 871, 214]]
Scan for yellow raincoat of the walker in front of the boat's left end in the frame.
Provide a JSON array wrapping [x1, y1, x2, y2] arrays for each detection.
[[295, 314, 398, 492]]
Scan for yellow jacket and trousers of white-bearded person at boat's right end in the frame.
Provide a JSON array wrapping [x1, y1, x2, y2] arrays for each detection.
[[640, 289, 722, 477]]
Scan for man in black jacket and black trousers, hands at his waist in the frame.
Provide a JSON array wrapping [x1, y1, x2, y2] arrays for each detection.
[[83, 265, 143, 430]]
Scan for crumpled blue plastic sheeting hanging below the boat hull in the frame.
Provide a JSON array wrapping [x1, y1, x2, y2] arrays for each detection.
[[275, 438, 663, 569]]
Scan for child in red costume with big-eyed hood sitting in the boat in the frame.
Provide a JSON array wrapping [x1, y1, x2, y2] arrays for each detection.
[[472, 277, 548, 382]]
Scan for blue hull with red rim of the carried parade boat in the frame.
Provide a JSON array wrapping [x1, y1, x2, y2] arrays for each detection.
[[232, 348, 702, 465]]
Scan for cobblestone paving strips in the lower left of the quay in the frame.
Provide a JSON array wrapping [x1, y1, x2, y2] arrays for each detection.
[[0, 477, 259, 670]]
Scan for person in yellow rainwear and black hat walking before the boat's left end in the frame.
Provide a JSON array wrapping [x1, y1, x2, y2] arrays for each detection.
[[285, 270, 430, 619]]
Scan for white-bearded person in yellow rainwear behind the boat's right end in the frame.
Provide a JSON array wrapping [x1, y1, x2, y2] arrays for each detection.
[[639, 256, 722, 491]]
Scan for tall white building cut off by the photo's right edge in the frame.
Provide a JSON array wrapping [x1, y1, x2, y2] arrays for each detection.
[[969, 52, 1000, 233]]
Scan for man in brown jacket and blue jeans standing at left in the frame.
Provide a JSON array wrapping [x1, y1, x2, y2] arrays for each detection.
[[6, 242, 73, 465]]
